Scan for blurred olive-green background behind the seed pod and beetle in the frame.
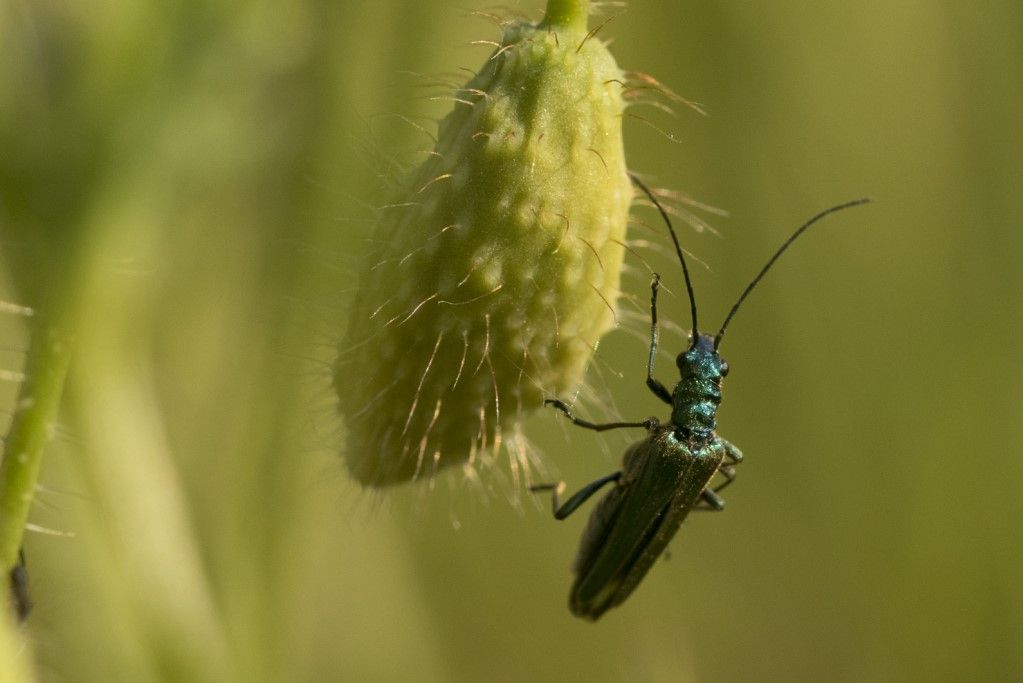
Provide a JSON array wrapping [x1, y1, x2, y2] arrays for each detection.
[[0, 0, 1021, 681]]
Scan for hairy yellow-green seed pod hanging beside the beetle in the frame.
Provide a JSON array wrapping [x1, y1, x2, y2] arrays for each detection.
[[334, 0, 633, 486]]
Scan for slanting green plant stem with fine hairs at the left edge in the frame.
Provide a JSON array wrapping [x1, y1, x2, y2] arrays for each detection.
[[0, 318, 71, 575]]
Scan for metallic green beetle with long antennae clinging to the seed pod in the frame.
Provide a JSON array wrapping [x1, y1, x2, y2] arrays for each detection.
[[530, 176, 869, 621]]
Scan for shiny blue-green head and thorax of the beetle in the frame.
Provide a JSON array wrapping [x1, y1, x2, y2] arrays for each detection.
[[672, 334, 729, 441]]
